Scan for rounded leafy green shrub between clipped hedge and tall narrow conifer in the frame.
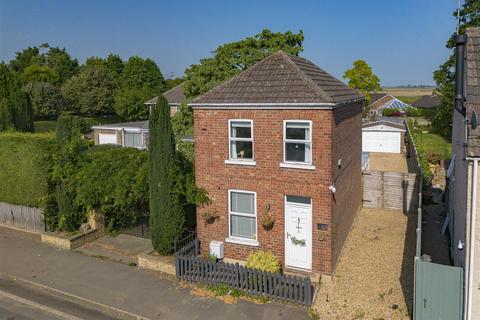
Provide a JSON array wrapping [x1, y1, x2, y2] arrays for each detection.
[[71, 146, 148, 231]]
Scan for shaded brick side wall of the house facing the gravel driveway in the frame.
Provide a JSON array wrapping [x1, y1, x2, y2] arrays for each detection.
[[332, 102, 362, 269]]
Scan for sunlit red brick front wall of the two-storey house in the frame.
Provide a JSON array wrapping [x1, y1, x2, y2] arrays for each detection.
[[194, 109, 361, 273]]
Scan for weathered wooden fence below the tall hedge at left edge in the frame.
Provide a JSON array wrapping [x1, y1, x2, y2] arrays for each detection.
[[0, 202, 45, 231]]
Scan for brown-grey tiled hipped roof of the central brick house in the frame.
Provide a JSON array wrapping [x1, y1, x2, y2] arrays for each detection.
[[192, 51, 363, 105]]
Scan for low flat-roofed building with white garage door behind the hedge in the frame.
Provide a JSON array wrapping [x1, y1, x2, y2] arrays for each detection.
[[92, 120, 148, 149]]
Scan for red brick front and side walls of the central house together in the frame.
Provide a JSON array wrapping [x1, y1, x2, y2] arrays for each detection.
[[194, 102, 362, 274]]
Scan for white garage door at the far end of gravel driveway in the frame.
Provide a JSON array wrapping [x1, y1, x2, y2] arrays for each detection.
[[362, 131, 401, 153]]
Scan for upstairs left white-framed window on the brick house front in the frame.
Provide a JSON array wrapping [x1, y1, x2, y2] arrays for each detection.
[[228, 119, 253, 161]]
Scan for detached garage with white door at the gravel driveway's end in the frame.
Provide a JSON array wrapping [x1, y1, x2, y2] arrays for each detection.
[[362, 120, 406, 153]]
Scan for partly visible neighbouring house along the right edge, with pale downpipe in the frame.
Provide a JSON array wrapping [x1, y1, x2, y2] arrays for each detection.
[[446, 28, 480, 320]]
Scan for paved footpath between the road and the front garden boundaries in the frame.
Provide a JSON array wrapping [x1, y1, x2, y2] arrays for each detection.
[[0, 228, 309, 320]]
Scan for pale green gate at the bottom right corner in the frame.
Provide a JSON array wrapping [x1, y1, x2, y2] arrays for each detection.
[[414, 257, 463, 320]]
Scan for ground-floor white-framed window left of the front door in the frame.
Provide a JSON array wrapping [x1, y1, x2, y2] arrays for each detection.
[[228, 190, 257, 240]]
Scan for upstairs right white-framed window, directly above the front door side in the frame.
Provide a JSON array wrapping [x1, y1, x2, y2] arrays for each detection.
[[283, 120, 312, 165]]
